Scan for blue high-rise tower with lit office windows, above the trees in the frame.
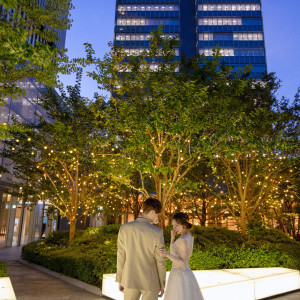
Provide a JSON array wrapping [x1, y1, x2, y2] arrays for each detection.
[[115, 0, 266, 78]]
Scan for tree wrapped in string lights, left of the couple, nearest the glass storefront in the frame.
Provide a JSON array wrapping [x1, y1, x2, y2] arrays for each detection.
[[2, 73, 105, 242]]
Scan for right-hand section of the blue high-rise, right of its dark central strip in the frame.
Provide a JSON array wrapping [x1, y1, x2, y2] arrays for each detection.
[[196, 0, 266, 78]]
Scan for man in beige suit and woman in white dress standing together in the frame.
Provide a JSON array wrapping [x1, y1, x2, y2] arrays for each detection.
[[116, 198, 203, 300]]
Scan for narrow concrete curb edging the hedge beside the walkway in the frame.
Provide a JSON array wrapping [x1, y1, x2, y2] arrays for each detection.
[[17, 258, 105, 297]]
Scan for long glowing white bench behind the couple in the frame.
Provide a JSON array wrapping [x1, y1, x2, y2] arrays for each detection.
[[102, 268, 300, 300]]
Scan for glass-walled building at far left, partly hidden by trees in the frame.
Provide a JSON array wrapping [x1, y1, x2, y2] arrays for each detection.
[[0, 0, 66, 248]]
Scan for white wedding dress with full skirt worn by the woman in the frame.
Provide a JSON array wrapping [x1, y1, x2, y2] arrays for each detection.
[[164, 233, 204, 300]]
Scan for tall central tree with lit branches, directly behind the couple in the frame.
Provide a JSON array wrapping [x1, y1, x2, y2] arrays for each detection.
[[81, 32, 221, 226]]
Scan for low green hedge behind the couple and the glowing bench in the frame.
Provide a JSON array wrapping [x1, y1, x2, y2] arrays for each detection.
[[22, 225, 300, 286]]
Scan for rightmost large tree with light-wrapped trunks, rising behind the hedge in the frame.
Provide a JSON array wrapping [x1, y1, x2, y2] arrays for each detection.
[[214, 74, 296, 234]]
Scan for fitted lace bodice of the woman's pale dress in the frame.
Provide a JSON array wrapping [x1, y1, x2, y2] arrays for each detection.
[[170, 233, 194, 270]]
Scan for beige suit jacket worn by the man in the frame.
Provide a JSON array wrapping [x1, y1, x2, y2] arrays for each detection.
[[116, 217, 166, 291]]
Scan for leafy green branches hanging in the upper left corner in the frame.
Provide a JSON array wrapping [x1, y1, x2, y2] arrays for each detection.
[[0, 0, 73, 102]]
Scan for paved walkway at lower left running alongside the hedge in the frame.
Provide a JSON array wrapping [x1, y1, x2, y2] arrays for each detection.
[[0, 247, 108, 300]]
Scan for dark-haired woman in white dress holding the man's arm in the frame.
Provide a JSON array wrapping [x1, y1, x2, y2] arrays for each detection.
[[159, 212, 204, 300]]
